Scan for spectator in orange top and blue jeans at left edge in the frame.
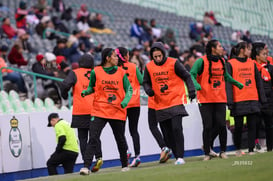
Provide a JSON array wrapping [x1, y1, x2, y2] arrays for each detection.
[[0, 45, 27, 94]]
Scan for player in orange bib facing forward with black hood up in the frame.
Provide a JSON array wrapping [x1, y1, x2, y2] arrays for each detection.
[[143, 42, 196, 165]]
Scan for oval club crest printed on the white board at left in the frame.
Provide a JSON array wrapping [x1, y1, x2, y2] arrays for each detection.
[[9, 116, 22, 157]]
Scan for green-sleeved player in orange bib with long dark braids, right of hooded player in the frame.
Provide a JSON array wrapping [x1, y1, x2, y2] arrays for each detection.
[[191, 40, 243, 161]]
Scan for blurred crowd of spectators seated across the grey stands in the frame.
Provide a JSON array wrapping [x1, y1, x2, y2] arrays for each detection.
[[0, 0, 270, 109]]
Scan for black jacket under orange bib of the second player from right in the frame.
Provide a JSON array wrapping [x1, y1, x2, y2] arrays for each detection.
[[226, 58, 266, 116]]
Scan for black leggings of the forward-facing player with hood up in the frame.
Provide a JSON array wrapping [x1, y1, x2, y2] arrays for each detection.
[[159, 115, 184, 159]]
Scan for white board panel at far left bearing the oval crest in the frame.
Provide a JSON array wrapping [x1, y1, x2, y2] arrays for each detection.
[[0, 114, 32, 173]]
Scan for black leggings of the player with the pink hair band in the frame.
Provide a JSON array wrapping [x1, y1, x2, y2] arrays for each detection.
[[127, 107, 140, 157]]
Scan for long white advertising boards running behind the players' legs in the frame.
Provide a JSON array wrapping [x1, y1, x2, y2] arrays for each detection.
[[0, 104, 232, 173]]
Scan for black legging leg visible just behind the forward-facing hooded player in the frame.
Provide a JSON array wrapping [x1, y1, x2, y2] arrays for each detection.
[[148, 108, 166, 149]]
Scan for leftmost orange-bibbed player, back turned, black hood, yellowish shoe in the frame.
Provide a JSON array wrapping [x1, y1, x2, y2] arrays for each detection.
[[60, 54, 103, 172]]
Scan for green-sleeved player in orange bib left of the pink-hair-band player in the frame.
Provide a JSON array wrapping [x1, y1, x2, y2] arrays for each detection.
[[80, 48, 133, 175]]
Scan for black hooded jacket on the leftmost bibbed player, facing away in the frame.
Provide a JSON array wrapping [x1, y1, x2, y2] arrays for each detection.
[[60, 54, 94, 129]]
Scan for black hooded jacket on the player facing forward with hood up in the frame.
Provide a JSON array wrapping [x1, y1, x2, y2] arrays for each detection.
[[143, 43, 195, 121]]
